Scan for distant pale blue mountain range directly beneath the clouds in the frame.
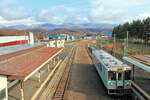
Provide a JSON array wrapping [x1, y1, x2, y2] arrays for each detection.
[[0, 23, 116, 30]]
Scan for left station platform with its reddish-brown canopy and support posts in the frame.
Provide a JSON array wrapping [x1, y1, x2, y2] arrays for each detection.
[[0, 45, 63, 100]]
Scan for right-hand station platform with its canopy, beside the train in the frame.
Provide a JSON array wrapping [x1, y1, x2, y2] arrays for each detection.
[[123, 55, 150, 100]]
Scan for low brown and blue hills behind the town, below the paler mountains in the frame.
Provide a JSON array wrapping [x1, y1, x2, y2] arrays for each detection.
[[0, 28, 111, 36]]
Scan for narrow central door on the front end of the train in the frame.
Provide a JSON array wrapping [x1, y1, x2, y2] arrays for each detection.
[[116, 72, 123, 88]]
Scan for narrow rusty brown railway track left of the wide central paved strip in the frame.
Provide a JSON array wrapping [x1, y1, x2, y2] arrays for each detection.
[[52, 47, 76, 100]]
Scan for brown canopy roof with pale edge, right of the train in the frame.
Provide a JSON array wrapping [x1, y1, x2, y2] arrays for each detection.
[[123, 55, 150, 72]]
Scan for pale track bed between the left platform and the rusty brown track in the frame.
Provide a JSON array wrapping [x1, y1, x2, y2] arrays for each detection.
[[31, 47, 74, 100]]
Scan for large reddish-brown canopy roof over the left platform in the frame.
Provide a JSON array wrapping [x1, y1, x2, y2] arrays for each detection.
[[0, 46, 62, 81]]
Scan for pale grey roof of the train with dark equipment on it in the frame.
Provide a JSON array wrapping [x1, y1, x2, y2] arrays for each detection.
[[93, 50, 127, 68]]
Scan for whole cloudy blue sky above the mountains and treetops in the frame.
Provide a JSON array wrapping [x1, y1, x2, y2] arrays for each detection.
[[0, 0, 150, 26]]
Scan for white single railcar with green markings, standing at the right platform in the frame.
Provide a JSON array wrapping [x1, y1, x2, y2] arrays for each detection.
[[89, 47, 132, 95]]
